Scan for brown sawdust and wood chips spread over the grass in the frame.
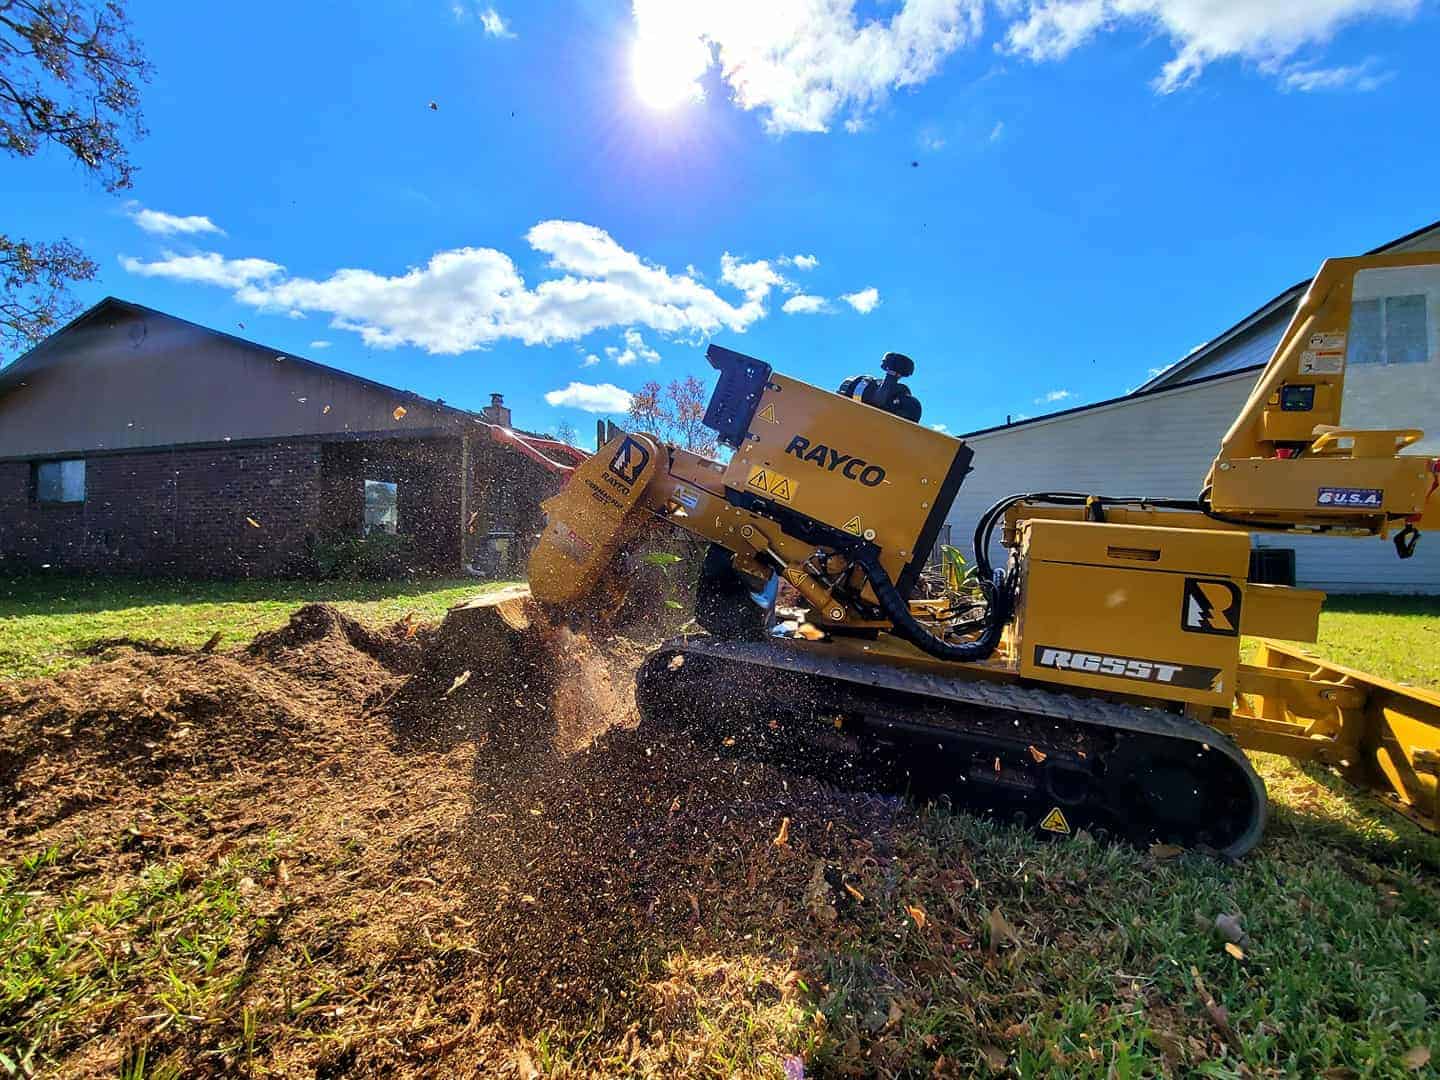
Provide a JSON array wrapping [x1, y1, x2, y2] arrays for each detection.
[[0, 605, 897, 1076]]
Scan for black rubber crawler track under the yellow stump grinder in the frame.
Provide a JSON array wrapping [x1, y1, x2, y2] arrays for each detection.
[[636, 639, 1266, 857]]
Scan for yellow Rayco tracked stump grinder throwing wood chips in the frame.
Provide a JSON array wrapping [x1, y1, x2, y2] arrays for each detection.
[[498, 252, 1440, 857]]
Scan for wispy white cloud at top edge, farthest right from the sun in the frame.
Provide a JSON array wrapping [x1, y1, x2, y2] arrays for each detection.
[[1005, 0, 1420, 94]]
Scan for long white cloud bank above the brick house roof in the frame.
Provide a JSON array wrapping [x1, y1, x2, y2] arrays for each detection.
[[121, 220, 783, 354]]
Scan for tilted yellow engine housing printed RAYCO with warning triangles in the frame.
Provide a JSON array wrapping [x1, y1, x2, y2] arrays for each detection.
[[724, 374, 971, 592]]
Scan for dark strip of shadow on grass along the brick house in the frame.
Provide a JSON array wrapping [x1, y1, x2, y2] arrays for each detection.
[[0, 575, 501, 618]]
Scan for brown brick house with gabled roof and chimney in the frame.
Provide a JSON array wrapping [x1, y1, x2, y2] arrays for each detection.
[[0, 298, 577, 576]]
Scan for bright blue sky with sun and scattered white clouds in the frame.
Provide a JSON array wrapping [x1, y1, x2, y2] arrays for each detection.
[[0, 0, 1440, 435]]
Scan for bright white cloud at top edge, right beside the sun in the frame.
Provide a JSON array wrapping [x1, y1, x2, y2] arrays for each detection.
[[634, 0, 984, 134]]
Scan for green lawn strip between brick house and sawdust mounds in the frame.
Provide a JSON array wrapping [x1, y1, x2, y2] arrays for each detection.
[[0, 576, 506, 680]]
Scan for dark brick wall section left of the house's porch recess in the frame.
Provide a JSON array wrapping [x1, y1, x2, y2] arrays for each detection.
[[0, 442, 321, 577]]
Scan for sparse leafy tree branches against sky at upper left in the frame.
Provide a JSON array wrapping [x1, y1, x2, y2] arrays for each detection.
[[0, 0, 150, 350]]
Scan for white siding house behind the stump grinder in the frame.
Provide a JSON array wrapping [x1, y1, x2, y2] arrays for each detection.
[[949, 222, 1440, 595]]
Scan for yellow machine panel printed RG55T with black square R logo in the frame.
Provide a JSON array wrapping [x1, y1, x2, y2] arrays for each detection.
[[1017, 520, 1250, 706]]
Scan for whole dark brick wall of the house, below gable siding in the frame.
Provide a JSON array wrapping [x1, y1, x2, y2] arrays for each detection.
[[0, 438, 559, 577]]
